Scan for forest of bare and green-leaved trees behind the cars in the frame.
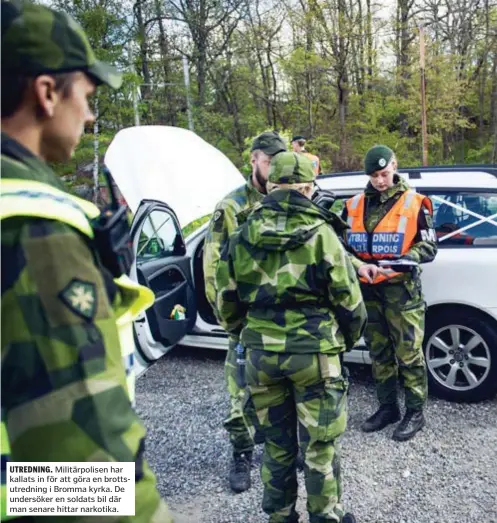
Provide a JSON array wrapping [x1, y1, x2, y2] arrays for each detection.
[[44, 0, 497, 200]]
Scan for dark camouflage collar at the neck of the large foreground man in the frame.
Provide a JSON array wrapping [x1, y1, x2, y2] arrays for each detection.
[[2, 132, 67, 192]]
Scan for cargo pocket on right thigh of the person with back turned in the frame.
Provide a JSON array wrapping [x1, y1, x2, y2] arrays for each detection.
[[317, 376, 348, 441]]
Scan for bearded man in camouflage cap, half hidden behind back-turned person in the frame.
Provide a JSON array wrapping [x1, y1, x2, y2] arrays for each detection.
[[203, 132, 286, 492]]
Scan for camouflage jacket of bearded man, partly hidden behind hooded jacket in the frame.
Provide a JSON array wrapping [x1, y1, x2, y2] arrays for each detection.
[[203, 180, 264, 315]]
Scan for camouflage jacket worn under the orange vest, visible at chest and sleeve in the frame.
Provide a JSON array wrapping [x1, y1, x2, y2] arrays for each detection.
[[342, 175, 438, 279]]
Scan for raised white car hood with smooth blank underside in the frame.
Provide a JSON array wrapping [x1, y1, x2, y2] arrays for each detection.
[[104, 126, 244, 227]]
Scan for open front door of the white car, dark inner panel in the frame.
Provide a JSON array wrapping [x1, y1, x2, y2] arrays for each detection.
[[131, 200, 197, 362]]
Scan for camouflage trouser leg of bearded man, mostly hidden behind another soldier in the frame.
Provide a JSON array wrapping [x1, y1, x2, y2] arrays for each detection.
[[224, 336, 254, 454]]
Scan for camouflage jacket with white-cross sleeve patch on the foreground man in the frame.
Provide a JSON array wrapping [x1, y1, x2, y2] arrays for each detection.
[[1, 135, 170, 523]]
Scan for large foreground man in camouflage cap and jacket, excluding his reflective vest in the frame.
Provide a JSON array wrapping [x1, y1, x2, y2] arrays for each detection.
[[1, 0, 172, 523]]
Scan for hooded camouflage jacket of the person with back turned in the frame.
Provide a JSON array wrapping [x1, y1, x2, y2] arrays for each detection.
[[216, 186, 366, 354]]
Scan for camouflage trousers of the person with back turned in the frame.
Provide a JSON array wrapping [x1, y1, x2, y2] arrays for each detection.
[[245, 349, 347, 523]]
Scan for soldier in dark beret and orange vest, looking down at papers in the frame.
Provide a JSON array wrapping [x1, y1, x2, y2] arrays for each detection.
[[342, 145, 437, 441]]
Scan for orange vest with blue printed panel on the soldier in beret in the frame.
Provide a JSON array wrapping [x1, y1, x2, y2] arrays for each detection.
[[346, 189, 432, 284]]
